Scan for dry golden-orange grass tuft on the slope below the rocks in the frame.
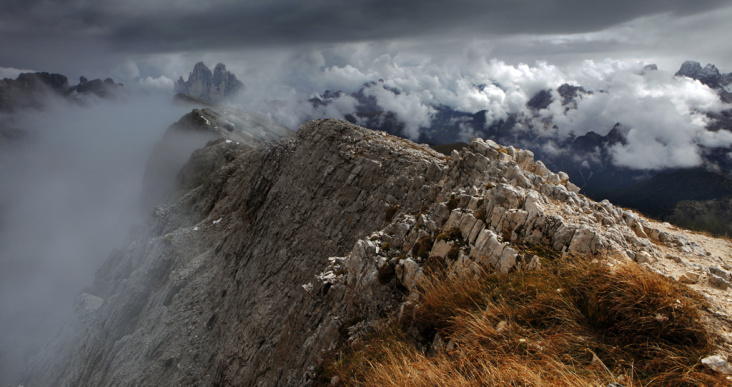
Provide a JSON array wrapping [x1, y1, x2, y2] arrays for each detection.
[[321, 253, 727, 387]]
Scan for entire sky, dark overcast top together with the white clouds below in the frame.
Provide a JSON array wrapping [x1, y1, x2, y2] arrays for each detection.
[[0, 0, 732, 170]]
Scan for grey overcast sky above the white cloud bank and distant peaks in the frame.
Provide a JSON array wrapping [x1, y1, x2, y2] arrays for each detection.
[[0, 0, 732, 82]]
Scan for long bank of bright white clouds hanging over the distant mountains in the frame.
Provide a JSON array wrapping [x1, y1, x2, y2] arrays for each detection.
[[160, 47, 732, 170]]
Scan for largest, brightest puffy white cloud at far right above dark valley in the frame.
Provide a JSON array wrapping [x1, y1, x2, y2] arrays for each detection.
[[549, 62, 729, 169]]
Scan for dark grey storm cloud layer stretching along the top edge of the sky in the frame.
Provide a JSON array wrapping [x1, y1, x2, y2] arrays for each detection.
[[0, 0, 728, 71]]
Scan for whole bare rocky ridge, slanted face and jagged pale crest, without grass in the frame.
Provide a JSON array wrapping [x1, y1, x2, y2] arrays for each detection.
[[24, 120, 732, 386]]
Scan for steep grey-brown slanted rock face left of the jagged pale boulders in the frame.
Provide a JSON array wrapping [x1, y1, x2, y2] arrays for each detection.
[[27, 121, 442, 385]]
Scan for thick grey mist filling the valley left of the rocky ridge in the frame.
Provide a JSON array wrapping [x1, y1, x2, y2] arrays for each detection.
[[0, 92, 190, 384]]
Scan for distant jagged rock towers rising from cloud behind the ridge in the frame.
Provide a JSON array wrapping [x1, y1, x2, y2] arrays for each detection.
[[175, 62, 244, 102]]
